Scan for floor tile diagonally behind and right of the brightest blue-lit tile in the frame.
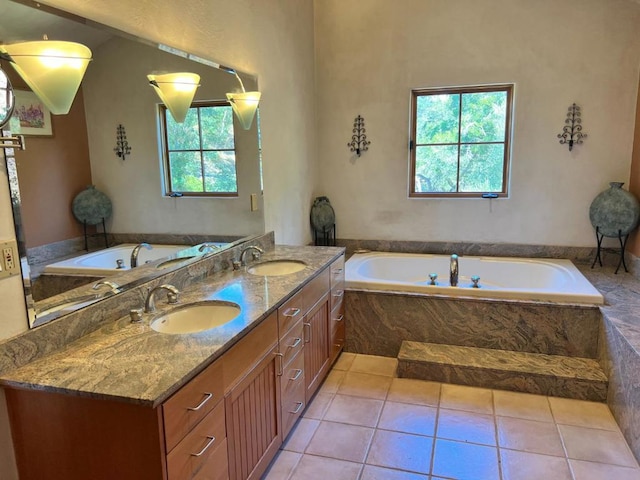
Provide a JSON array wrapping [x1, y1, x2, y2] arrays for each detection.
[[496, 417, 564, 457]]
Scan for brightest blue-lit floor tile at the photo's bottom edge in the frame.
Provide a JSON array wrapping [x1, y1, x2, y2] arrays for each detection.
[[432, 438, 500, 480]]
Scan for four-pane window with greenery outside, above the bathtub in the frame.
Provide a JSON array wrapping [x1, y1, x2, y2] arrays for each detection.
[[409, 85, 513, 197]]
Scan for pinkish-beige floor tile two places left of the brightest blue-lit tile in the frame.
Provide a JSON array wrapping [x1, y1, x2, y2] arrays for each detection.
[[306, 421, 374, 463]]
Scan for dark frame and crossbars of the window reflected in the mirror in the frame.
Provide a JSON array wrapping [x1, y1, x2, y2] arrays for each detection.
[[158, 100, 239, 198]]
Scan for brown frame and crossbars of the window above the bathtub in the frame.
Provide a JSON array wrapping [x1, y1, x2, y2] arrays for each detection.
[[409, 83, 515, 198]]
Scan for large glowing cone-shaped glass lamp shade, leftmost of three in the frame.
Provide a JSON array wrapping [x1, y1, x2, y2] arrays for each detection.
[[0, 40, 91, 115]]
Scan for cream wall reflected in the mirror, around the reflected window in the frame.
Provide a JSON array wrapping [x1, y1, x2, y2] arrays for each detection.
[[82, 37, 264, 236]]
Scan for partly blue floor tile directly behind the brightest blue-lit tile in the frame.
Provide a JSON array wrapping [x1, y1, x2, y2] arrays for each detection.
[[436, 408, 496, 446]]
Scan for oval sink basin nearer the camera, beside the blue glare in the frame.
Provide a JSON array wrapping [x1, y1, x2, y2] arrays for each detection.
[[151, 301, 240, 334]]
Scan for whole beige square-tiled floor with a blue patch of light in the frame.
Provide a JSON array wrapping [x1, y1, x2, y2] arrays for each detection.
[[263, 353, 640, 480]]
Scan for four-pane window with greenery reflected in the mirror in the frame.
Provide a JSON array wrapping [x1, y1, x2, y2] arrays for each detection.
[[160, 101, 238, 197]]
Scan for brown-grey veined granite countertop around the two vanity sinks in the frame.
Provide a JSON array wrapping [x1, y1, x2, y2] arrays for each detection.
[[0, 246, 344, 407]]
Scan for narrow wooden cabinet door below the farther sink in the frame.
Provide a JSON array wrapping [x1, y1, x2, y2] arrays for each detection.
[[304, 294, 329, 403]]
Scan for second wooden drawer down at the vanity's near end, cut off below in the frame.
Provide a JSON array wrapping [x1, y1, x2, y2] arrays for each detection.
[[167, 402, 228, 480]]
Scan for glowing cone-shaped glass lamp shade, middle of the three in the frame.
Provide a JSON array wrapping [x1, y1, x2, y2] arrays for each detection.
[[147, 72, 200, 123]]
